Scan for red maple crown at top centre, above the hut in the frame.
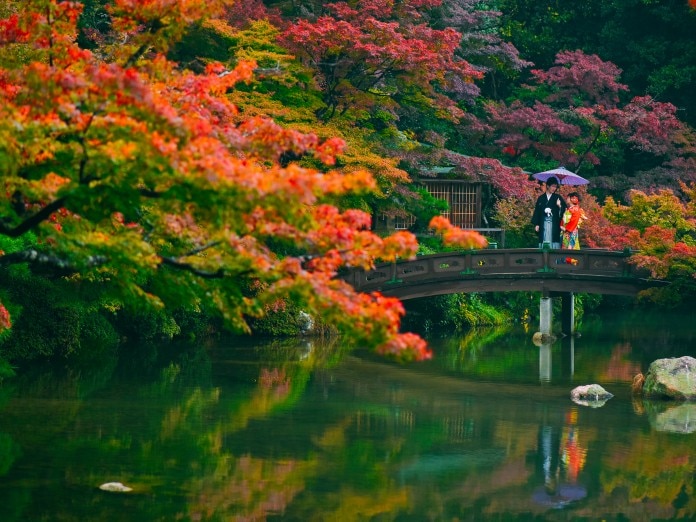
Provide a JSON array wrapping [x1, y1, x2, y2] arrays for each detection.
[[283, 0, 483, 119]]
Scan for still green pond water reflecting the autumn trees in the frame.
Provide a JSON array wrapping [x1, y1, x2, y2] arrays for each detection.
[[0, 311, 696, 522]]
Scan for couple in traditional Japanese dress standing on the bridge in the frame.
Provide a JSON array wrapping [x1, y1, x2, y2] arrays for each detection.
[[532, 177, 586, 250]]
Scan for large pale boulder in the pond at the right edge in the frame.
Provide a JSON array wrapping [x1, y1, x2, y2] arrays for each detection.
[[643, 356, 696, 401]]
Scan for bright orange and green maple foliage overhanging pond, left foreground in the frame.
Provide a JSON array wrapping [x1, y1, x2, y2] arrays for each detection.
[[0, 0, 452, 359]]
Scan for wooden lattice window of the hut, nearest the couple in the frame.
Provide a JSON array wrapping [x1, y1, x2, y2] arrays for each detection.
[[425, 180, 481, 228]]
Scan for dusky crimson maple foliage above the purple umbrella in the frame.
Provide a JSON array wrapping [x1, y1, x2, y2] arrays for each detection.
[[485, 50, 695, 184]]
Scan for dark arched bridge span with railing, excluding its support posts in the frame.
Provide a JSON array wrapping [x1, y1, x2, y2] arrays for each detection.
[[343, 248, 667, 300]]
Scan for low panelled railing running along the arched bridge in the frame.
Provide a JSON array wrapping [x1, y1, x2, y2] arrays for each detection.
[[344, 248, 648, 291]]
